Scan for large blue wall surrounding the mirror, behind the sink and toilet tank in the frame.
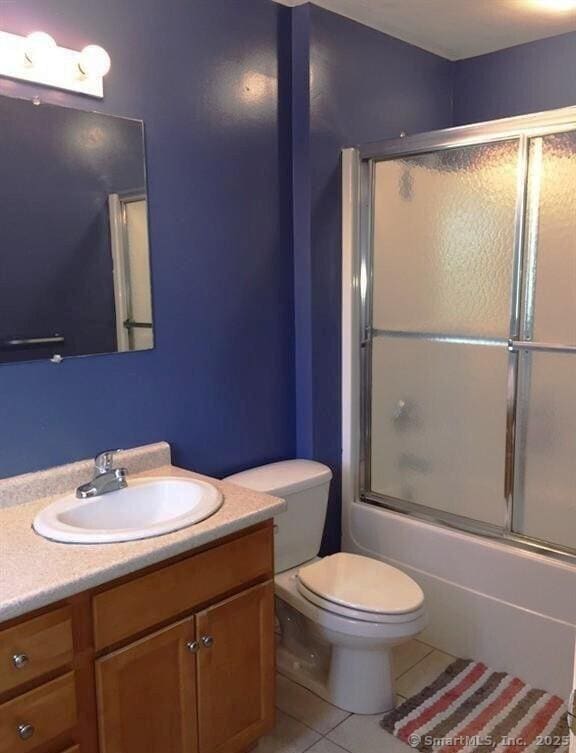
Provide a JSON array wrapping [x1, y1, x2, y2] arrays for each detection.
[[0, 0, 295, 476]]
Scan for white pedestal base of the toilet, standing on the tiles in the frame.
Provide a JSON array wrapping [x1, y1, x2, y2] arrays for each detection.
[[276, 644, 396, 714]]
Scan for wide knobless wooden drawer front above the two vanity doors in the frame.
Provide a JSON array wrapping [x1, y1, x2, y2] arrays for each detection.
[[93, 525, 274, 650]]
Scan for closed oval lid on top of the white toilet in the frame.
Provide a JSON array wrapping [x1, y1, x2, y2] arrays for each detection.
[[298, 552, 424, 614]]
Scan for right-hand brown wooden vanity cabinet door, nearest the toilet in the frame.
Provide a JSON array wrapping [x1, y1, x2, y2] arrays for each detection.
[[196, 582, 274, 753]]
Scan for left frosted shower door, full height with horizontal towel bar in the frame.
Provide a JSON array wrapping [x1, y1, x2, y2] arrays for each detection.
[[364, 139, 523, 529]]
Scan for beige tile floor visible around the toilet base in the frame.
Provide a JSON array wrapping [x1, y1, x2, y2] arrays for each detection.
[[256, 641, 454, 753]]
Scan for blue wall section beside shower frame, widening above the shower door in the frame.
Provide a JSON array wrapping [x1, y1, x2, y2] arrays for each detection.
[[295, 6, 452, 551]]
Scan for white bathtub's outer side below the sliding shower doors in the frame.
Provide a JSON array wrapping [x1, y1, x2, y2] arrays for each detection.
[[343, 503, 576, 697]]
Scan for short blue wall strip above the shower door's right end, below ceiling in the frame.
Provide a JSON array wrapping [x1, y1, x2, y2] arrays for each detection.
[[454, 32, 576, 125]]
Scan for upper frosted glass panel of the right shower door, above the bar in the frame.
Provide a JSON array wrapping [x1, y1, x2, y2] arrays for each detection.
[[530, 133, 576, 344]]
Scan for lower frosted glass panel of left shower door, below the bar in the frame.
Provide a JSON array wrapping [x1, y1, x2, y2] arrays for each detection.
[[371, 337, 507, 525]]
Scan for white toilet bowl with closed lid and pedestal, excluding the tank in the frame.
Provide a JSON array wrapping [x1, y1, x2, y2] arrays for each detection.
[[275, 554, 426, 714]]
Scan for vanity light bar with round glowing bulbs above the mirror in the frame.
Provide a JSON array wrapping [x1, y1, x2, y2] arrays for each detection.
[[0, 31, 111, 99]]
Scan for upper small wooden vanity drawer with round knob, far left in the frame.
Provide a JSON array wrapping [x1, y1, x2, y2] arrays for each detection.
[[0, 607, 73, 693]]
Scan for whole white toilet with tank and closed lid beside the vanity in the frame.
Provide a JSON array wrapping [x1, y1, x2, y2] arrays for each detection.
[[226, 460, 426, 714]]
